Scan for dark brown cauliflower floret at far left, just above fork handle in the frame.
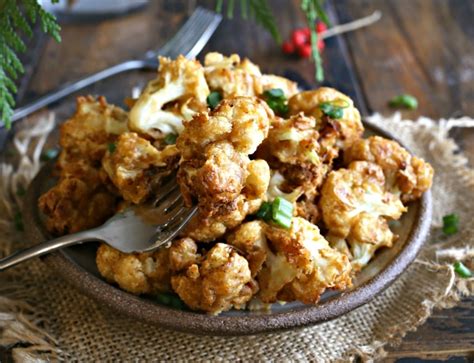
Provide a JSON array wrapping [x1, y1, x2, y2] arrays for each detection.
[[38, 160, 117, 235]]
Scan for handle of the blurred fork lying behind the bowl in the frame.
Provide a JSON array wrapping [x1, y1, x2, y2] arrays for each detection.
[[12, 59, 157, 122]]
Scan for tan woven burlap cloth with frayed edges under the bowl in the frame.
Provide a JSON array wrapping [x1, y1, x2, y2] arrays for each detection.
[[0, 115, 474, 361]]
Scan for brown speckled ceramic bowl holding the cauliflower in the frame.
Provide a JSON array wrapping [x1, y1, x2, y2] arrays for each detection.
[[25, 124, 431, 335]]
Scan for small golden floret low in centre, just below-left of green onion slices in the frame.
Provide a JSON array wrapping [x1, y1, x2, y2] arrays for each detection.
[[226, 221, 268, 277]]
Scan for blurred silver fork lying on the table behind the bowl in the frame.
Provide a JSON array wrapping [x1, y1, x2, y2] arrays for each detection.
[[7, 7, 222, 127]]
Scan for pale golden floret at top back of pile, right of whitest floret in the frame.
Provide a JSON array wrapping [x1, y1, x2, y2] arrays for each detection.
[[204, 52, 298, 98]]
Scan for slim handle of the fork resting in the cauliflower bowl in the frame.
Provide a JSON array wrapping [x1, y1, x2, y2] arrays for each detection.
[[0, 232, 99, 272]]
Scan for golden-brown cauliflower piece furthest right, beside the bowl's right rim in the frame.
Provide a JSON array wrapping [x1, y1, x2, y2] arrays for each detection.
[[344, 136, 434, 203]]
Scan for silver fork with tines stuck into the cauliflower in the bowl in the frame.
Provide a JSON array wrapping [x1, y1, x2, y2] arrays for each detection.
[[0, 178, 197, 271]]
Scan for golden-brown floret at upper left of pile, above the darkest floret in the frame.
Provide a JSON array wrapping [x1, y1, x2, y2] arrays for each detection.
[[59, 96, 128, 166]]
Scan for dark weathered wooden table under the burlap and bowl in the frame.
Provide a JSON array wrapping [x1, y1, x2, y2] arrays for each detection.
[[12, 0, 474, 362]]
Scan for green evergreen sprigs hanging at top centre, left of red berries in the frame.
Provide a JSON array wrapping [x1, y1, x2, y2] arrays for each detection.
[[216, 0, 330, 82]]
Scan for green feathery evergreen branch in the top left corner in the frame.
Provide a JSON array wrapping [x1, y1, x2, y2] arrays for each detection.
[[0, 0, 61, 128]]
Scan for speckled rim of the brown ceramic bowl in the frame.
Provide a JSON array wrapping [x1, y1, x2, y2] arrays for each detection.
[[24, 121, 432, 336]]
